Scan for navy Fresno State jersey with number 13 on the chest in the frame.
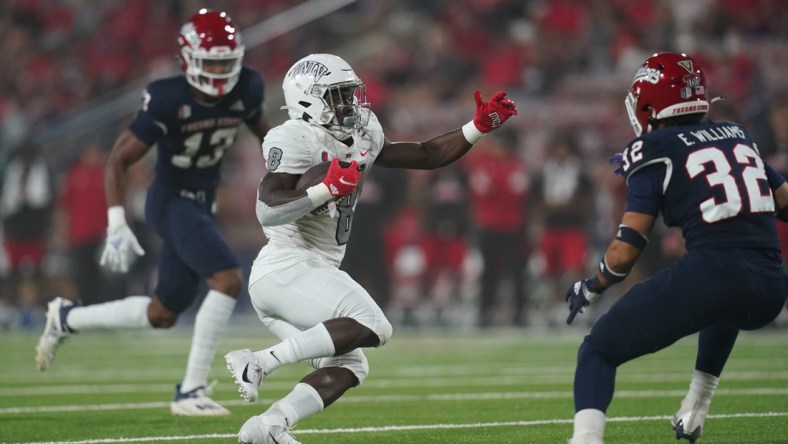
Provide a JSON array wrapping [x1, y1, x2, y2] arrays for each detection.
[[129, 66, 263, 190]]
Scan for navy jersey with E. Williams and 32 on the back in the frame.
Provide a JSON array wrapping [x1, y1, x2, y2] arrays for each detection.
[[622, 121, 779, 251]]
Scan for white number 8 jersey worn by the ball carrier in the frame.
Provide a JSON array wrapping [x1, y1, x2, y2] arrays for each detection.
[[260, 112, 384, 267]]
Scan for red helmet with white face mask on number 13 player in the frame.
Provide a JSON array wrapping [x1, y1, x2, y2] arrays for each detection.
[[178, 9, 244, 97]]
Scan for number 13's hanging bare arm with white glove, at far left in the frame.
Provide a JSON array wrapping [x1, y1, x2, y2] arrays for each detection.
[[100, 129, 150, 273]]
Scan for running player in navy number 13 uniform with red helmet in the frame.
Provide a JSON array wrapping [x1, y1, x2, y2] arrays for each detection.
[[36, 9, 269, 416]]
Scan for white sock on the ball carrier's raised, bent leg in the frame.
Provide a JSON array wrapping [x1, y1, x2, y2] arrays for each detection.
[[254, 323, 336, 374]]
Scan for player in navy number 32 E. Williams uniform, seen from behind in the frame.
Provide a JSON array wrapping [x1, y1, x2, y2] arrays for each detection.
[[566, 53, 788, 444]]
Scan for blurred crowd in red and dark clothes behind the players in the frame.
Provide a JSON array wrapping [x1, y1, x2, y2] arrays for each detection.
[[0, 0, 788, 329]]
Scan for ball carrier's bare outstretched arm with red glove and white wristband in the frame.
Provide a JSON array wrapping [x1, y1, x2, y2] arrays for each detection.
[[375, 90, 517, 170]]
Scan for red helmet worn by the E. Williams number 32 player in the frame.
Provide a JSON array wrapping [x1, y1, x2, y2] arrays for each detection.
[[624, 52, 709, 136]]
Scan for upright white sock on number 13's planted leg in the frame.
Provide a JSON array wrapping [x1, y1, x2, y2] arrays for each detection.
[[181, 290, 236, 393]]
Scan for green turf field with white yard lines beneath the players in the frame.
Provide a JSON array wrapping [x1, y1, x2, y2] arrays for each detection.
[[0, 324, 788, 444]]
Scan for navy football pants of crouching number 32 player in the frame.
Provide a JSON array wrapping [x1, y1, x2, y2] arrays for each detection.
[[574, 249, 788, 412]]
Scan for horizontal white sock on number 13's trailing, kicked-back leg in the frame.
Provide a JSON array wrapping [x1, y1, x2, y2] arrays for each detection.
[[66, 296, 153, 331]]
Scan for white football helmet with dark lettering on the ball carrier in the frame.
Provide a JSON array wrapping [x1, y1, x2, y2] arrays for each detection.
[[282, 54, 369, 140]]
